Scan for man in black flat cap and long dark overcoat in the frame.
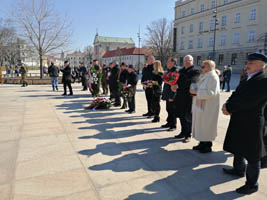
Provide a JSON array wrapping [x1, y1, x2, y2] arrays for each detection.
[[222, 53, 267, 194]]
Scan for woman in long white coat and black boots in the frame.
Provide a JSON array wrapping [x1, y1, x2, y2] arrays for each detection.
[[190, 60, 220, 153]]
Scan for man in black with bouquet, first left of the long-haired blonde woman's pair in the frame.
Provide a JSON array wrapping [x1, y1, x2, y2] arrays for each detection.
[[126, 65, 138, 114]]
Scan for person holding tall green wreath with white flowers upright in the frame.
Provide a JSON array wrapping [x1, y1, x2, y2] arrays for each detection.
[[90, 60, 102, 97]]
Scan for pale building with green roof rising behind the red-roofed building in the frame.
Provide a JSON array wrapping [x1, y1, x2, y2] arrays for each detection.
[[94, 34, 135, 64]]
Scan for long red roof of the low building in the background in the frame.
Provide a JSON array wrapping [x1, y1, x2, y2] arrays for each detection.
[[103, 47, 152, 58]]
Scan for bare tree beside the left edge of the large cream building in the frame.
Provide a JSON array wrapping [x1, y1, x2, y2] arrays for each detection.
[[145, 18, 173, 64]]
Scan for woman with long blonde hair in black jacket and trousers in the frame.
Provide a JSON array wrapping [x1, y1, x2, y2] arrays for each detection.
[[149, 60, 164, 123]]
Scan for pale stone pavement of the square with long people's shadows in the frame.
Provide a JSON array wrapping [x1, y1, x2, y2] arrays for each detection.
[[0, 82, 267, 200]]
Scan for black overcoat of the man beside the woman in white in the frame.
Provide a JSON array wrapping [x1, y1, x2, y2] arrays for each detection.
[[174, 66, 201, 121]]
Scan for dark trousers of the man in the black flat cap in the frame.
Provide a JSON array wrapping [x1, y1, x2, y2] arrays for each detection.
[[233, 155, 261, 187]]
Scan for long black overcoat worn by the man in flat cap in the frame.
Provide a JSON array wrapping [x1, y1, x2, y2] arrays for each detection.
[[223, 72, 267, 162]]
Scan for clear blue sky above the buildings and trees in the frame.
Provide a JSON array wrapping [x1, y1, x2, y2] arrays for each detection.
[[0, 0, 175, 50]]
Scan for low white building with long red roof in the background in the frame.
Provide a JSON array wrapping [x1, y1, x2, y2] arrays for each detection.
[[102, 47, 152, 72]]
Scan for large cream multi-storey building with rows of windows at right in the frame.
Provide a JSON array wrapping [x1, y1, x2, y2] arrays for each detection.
[[173, 0, 267, 72]]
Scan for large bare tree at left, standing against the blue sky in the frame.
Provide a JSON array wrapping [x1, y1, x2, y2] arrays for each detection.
[[12, 0, 72, 78]]
